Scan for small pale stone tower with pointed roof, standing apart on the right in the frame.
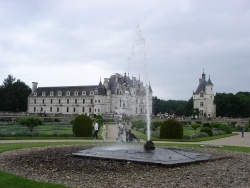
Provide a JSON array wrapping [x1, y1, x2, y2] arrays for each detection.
[[193, 71, 216, 118]]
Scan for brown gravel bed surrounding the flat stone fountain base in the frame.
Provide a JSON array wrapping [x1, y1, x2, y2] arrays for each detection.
[[0, 146, 250, 188]]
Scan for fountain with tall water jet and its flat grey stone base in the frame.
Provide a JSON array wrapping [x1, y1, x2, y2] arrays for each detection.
[[73, 26, 222, 166]]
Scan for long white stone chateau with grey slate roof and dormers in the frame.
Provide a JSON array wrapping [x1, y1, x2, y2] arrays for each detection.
[[28, 73, 152, 116]]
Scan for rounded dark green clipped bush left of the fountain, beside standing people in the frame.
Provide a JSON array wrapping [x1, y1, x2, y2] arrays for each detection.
[[72, 114, 93, 137]]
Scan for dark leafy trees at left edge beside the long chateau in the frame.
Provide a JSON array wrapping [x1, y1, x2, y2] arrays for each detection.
[[0, 75, 31, 112]]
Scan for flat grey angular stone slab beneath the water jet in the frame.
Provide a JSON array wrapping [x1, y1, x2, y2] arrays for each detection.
[[73, 145, 221, 166]]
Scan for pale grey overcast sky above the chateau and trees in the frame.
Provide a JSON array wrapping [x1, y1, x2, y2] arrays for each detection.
[[0, 0, 250, 100]]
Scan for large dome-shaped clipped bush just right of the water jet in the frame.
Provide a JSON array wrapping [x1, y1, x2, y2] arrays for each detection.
[[160, 119, 183, 139]]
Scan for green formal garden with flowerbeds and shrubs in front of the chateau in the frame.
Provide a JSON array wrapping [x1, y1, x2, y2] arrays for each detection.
[[0, 116, 249, 142]]
